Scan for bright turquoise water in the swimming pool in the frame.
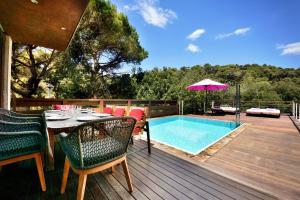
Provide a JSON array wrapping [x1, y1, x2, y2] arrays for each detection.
[[149, 116, 236, 155]]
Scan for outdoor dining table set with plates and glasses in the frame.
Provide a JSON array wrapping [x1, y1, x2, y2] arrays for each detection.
[[45, 110, 113, 170]]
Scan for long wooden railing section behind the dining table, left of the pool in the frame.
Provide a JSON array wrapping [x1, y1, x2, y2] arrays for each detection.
[[12, 98, 178, 117]]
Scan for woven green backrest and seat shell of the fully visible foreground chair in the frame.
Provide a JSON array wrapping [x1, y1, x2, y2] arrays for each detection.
[[62, 117, 136, 168]]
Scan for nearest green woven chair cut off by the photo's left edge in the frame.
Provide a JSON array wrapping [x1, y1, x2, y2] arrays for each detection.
[[0, 120, 46, 191]]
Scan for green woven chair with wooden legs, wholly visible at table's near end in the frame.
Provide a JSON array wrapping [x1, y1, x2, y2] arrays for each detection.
[[60, 117, 136, 200]]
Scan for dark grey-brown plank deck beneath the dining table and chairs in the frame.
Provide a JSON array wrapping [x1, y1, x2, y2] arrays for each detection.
[[0, 141, 274, 200]]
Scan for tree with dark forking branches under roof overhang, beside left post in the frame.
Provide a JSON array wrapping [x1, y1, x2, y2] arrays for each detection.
[[11, 43, 60, 98]]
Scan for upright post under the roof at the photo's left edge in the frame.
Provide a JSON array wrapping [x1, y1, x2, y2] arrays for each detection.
[[0, 34, 12, 110]]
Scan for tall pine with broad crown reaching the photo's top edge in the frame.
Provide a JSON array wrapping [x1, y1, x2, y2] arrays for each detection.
[[69, 0, 148, 97]]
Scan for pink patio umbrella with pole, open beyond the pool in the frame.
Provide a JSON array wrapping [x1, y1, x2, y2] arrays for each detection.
[[187, 79, 229, 112]]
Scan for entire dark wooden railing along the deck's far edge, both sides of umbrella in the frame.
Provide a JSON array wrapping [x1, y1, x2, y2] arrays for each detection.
[[12, 98, 294, 116]]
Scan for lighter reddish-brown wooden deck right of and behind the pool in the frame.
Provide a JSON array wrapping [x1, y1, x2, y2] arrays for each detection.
[[196, 115, 300, 199]]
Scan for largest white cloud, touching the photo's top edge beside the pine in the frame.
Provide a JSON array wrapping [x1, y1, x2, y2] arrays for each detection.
[[124, 0, 177, 28]]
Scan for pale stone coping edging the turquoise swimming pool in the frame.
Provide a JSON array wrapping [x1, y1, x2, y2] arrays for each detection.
[[142, 115, 243, 156]]
